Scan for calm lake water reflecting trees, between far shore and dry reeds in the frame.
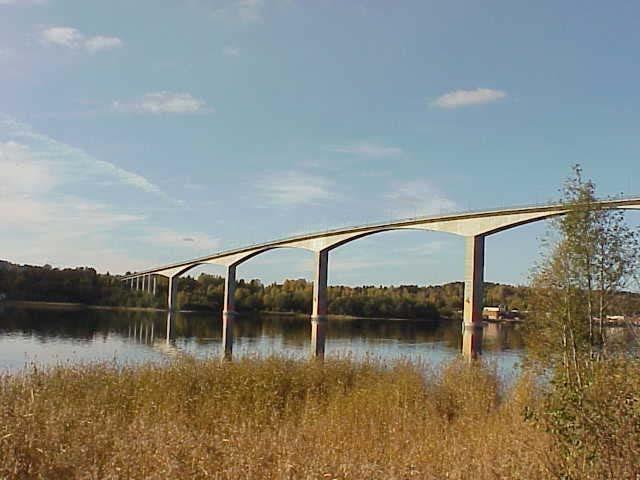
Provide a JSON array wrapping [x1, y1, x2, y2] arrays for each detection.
[[0, 307, 522, 376]]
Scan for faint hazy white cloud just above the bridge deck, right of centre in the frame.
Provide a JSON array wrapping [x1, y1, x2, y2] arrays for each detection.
[[385, 180, 457, 218]]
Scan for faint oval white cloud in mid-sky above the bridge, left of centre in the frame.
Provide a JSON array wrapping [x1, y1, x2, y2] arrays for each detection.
[[258, 171, 336, 206]]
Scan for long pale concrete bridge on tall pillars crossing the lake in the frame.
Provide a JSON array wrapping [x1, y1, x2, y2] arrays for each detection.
[[122, 197, 640, 358]]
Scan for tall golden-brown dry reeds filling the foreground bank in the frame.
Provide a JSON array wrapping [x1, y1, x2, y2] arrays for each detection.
[[0, 358, 558, 480]]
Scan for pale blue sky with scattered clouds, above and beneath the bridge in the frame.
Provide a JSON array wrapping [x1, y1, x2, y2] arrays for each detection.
[[0, 0, 640, 285]]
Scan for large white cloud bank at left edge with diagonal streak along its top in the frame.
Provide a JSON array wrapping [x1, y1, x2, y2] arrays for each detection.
[[0, 128, 191, 272]]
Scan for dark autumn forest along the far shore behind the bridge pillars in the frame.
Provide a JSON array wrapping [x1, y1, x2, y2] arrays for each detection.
[[0, 261, 640, 319]]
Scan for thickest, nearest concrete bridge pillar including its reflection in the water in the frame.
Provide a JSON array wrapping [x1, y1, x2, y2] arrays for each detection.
[[462, 235, 485, 359]]
